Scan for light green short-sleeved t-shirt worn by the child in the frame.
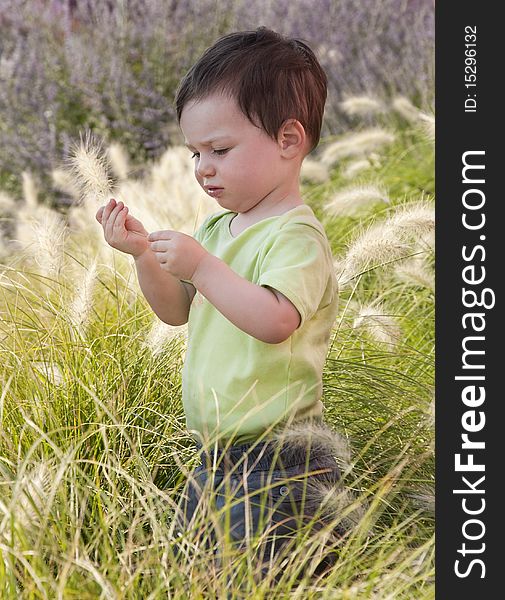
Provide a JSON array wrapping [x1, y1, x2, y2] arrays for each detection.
[[182, 204, 338, 444]]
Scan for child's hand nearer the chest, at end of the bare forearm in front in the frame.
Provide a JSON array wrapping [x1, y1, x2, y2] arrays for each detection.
[[147, 229, 208, 281]]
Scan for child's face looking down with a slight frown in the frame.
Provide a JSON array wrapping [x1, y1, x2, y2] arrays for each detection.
[[180, 94, 293, 212]]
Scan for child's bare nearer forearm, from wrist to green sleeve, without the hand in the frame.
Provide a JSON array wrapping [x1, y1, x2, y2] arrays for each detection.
[[191, 254, 300, 344]]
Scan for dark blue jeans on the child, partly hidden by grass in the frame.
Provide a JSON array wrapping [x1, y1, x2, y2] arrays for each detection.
[[172, 432, 343, 573]]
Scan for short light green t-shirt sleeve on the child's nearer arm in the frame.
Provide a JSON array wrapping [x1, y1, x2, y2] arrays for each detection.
[[257, 224, 332, 327]]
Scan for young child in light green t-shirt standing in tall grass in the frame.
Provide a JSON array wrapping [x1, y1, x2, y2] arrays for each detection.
[[96, 27, 340, 580]]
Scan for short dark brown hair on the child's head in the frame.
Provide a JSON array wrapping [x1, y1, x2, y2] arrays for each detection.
[[175, 26, 328, 152]]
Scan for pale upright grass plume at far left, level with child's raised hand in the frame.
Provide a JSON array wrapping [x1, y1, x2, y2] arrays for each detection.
[[29, 209, 67, 277]]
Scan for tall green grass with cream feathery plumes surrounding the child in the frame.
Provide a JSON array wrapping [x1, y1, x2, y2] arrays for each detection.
[[0, 103, 434, 600]]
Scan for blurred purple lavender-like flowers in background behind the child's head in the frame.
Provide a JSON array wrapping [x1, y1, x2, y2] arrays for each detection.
[[0, 0, 434, 204]]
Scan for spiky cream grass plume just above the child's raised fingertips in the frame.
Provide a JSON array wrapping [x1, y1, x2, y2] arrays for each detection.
[[65, 130, 114, 208]]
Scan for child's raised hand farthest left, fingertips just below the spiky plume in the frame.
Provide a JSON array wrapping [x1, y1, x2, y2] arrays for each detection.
[[95, 198, 149, 258]]
